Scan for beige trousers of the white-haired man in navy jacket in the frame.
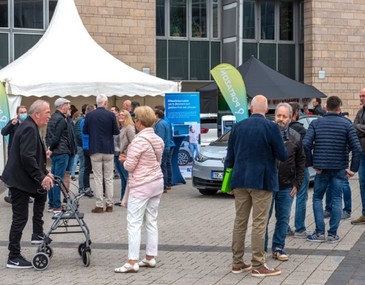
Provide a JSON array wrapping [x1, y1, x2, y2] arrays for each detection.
[[90, 153, 114, 208]]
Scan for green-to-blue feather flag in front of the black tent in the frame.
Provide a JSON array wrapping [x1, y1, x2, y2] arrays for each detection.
[[210, 63, 248, 122]]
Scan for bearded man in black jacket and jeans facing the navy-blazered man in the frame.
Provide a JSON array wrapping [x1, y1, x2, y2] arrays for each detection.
[[265, 103, 305, 261]]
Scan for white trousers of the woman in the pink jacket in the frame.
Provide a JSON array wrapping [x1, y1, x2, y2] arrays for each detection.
[[127, 195, 161, 260]]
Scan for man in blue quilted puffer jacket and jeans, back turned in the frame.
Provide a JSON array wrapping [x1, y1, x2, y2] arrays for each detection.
[[303, 96, 361, 243]]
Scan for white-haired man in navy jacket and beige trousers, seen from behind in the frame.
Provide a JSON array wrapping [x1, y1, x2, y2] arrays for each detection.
[[83, 95, 120, 213]]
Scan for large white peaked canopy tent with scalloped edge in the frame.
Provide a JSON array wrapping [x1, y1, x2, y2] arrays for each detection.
[[0, 0, 181, 173]]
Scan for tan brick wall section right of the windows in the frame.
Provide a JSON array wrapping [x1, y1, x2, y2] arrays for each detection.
[[304, 0, 365, 119]]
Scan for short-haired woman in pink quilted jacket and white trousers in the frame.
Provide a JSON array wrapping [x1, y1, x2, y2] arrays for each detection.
[[114, 106, 164, 273]]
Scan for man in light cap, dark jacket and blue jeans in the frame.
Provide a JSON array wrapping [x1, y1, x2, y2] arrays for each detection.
[[46, 98, 76, 212]]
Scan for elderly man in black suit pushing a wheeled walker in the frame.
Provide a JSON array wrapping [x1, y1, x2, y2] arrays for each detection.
[[2, 100, 53, 268]]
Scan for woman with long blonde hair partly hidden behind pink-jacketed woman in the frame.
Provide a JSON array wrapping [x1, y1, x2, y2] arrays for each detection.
[[114, 110, 136, 207]]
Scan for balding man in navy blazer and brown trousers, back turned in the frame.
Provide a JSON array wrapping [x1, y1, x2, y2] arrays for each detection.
[[224, 95, 288, 277]]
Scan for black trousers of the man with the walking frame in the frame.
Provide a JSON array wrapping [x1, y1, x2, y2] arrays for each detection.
[[8, 187, 47, 258]]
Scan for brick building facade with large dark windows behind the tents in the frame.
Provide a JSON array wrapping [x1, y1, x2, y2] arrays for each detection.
[[0, 0, 365, 117]]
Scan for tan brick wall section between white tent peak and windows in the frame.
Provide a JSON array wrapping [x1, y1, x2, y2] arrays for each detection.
[[75, 0, 156, 75]]
